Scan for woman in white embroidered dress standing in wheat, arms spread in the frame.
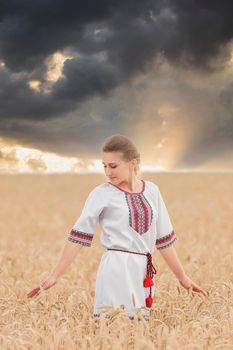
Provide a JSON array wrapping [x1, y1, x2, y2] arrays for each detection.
[[27, 134, 208, 320]]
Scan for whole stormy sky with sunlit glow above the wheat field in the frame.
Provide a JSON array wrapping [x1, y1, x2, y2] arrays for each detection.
[[0, 0, 233, 174]]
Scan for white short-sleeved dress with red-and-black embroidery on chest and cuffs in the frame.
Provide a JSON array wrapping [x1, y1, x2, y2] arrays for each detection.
[[68, 180, 177, 317]]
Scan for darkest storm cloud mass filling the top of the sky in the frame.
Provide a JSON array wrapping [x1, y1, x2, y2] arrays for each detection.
[[0, 0, 233, 119]]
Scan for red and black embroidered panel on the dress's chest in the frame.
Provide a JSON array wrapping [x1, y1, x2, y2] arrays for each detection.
[[125, 192, 153, 235]]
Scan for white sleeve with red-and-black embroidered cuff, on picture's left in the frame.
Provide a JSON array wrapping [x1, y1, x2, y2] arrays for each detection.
[[67, 189, 103, 247]]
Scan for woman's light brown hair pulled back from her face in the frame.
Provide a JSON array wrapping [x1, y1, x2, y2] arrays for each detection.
[[101, 134, 140, 174]]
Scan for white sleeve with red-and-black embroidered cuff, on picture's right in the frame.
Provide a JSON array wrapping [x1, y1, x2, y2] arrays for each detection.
[[155, 189, 177, 249]]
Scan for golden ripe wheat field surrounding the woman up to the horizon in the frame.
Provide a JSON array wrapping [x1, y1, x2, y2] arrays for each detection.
[[0, 173, 233, 350]]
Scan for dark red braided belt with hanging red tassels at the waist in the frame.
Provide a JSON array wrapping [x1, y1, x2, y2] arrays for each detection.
[[107, 248, 157, 307]]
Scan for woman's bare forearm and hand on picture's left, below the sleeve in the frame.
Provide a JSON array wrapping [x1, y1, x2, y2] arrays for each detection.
[[27, 240, 83, 298]]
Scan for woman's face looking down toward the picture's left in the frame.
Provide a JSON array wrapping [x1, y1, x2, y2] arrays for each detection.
[[102, 152, 137, 184]]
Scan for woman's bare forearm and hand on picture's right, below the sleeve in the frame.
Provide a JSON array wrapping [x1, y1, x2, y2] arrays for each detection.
[[159, 244, 208, 296]]
